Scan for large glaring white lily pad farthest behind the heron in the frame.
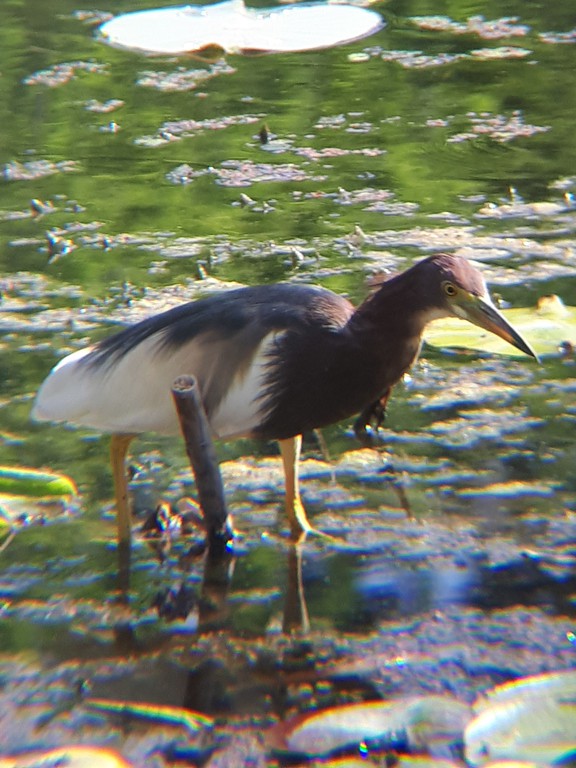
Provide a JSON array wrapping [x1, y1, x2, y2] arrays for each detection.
[[99, 0, 384, 55]]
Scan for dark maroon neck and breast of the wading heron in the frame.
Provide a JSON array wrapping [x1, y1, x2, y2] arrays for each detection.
[[254, 268, 434, 439]]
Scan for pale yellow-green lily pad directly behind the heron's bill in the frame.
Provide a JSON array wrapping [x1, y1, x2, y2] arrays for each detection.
[[424, 296, 576, 357]]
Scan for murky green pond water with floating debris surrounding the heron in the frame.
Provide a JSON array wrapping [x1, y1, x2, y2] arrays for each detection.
[[0, 2, 576, 765]]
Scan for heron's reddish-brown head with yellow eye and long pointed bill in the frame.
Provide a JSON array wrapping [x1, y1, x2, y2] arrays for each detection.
[[420, 254, 538, 359]]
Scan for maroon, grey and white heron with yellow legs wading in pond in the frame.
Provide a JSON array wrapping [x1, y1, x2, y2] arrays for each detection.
[[32, 253, 536, 541]]
